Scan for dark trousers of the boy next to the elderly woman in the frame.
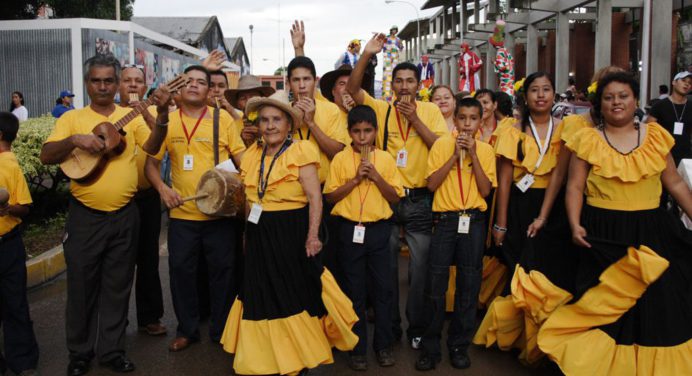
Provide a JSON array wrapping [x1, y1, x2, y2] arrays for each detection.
[[335, 219, 394, 355]]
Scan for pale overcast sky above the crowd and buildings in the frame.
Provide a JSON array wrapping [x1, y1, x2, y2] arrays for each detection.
[[134, 0, 437, 79]]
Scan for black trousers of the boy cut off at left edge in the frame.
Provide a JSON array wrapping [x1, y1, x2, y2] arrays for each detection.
[[0, 230, 38, 374]]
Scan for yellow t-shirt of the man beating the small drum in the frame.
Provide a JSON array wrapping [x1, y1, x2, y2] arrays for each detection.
[[155, 107, 245, 221]]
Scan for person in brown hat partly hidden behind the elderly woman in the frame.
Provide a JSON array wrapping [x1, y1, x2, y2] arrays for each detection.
[[224, 75, 274, 147]]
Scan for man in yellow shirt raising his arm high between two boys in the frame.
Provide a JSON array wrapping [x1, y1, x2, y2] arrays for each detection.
[[346, 34, 447, 348]]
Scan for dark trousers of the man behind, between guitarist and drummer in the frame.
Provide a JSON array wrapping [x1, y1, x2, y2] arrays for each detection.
[[135, 188, 163, 326]]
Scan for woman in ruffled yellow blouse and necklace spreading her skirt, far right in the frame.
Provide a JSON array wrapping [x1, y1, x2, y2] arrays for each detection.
[[538, 73, 692, 375]]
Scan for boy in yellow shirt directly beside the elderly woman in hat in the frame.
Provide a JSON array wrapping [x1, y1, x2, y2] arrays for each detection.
[[324, 105, 404, 371]]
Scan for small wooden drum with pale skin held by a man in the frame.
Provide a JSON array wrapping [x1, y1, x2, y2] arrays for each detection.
[[195, 168, 245, 217]]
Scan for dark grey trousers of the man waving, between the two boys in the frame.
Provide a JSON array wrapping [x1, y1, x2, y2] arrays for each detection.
[[389, 192, 433, 338]]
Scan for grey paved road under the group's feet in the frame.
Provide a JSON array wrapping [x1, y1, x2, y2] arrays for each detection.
[[24, 235, 560, 376]]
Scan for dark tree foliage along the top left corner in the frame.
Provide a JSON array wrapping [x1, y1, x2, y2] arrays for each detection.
[[0, 0, 135, 21]]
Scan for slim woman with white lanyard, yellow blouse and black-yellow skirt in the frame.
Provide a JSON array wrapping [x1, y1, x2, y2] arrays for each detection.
[[474, 72, 576, 363]]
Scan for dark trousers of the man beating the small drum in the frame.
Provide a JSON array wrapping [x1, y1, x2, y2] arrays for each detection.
[[168, 219, 237, 342]]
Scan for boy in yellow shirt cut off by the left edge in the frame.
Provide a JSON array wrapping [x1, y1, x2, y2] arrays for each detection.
[[0, 112, 38, 375]]
